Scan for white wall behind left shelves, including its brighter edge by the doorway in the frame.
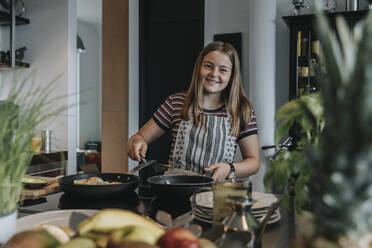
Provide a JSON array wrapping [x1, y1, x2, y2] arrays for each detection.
[[0, 0, 76, 173]]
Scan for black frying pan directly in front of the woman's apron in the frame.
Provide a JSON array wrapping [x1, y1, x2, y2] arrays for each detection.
[[147, 175, 214, 200]]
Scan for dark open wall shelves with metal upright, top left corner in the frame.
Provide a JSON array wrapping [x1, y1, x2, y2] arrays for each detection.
[[0, 0, 30, 70]]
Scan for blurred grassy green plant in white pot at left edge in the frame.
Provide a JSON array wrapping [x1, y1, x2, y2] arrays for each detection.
[[0, 72, 66, 243]]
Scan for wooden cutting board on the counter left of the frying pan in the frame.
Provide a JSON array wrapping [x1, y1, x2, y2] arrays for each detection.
[[21, 176, 63, 200]]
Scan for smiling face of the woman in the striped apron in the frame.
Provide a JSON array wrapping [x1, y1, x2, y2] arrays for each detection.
[[200, 51, 232, 94]]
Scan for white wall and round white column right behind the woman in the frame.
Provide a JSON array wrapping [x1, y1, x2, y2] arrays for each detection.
[[205, 0, 275, 191]]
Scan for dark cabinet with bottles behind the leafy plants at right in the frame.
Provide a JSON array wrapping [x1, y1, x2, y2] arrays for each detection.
[[283, 10, 368, 100]]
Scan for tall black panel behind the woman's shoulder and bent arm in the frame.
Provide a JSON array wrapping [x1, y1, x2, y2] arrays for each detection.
[[139, 0, 205, 163]]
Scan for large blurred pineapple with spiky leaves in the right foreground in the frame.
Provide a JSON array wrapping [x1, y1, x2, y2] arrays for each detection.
[[308, 4, 372, 244]]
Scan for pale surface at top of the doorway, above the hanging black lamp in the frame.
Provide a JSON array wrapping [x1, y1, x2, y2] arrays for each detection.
[[77, 0, 102, 25]]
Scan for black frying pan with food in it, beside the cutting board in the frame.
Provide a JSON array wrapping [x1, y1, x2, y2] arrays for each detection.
[[59, 173, 138, 198]]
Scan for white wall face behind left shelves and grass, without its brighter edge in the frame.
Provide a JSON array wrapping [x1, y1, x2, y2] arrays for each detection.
[[0, 0, 72, 150]]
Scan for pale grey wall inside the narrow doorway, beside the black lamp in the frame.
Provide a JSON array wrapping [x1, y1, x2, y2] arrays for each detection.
[[77, 21, 101, 149]]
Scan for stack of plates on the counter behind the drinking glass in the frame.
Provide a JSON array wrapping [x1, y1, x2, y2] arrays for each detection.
[[191, 191, 280, 224]]
